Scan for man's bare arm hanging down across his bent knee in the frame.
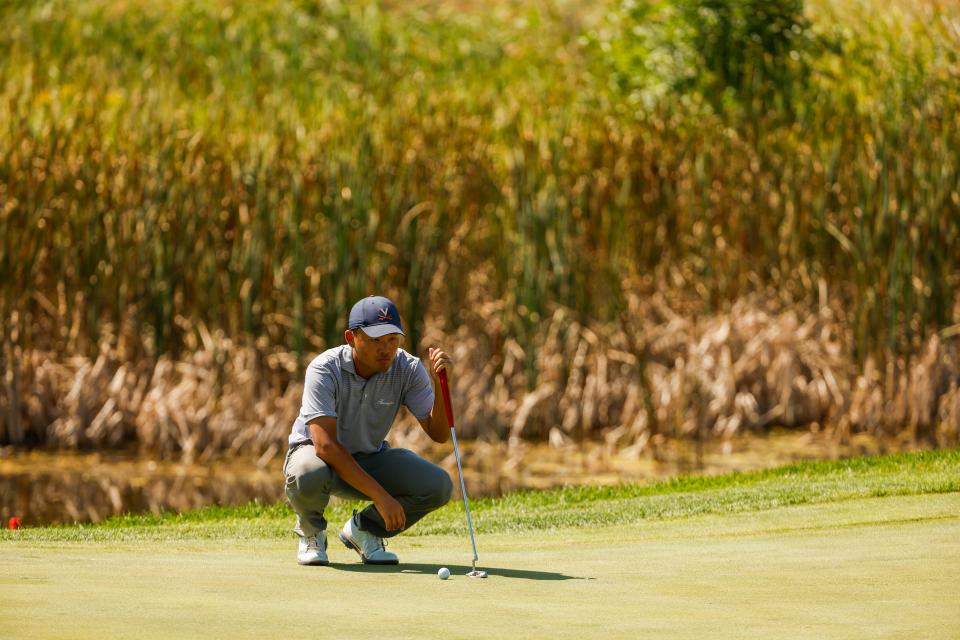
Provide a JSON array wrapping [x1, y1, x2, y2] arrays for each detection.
[[308, 416, 406, 531]]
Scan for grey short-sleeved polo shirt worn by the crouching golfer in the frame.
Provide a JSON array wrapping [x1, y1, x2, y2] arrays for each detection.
[[289, 344, 434, 453]]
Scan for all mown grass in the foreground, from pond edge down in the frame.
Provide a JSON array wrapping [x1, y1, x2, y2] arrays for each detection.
[[0, 454, 960, 639]]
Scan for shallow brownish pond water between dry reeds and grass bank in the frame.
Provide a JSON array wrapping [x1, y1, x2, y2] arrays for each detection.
[[0, 431, 918, 526]]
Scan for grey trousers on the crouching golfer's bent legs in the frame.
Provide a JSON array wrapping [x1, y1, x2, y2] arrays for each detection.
[[283, 442, 453, 538]]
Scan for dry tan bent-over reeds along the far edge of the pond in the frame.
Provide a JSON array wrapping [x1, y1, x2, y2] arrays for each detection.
[[0, 295, 960, 460]]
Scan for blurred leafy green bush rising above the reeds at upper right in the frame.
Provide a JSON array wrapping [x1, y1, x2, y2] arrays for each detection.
[[584, 0, 818, 118]]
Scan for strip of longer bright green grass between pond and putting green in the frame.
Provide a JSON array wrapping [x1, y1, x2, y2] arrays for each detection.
[[0, 450, 960, 544]]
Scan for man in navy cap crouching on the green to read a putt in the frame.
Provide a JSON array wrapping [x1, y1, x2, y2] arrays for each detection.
[[283, 296, 453, 565]]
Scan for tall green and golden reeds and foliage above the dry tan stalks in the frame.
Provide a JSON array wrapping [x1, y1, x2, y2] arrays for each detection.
[[0, 0, 960, 460]]
